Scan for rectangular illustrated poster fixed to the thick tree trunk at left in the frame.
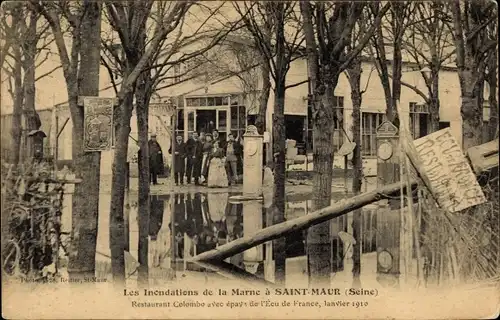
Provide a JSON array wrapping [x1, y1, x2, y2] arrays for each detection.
[[83, 97, 114, 152]]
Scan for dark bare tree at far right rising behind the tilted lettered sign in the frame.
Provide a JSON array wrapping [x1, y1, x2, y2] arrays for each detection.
[[449, 0, 498, 150]]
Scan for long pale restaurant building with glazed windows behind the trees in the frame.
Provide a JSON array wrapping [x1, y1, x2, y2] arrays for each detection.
[[2, 53, 488, 180]]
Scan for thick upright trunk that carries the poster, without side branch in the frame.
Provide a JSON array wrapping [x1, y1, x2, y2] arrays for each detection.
[[67, 1, 101, 278]]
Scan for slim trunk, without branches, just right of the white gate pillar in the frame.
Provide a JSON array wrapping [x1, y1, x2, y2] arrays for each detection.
[[271, 81, 286, 283]]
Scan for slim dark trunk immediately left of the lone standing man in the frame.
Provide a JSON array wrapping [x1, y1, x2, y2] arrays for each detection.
[[136, 77, 150, 286]]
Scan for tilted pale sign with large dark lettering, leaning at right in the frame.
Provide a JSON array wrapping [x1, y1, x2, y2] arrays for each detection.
[[413, 128, 486, 212]]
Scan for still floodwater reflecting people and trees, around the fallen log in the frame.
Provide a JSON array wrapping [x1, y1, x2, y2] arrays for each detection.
[[63, 192, 386, 286]]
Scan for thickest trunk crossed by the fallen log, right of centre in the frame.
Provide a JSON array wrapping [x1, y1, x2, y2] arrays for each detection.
[[307, 76, 336, 286]]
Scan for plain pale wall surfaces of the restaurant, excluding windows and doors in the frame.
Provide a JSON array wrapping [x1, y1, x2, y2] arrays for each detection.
[[44, 55, 461, 178]]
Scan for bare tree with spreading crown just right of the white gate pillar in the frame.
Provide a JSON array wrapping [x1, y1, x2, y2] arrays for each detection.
[[233, 2, 304, 283]]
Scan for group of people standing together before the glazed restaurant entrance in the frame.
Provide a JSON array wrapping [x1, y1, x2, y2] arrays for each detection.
[[169, 129, 243, 186]]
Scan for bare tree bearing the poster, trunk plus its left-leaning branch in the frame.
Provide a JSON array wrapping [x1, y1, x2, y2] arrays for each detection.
[[30, 0, 101, 278]]
